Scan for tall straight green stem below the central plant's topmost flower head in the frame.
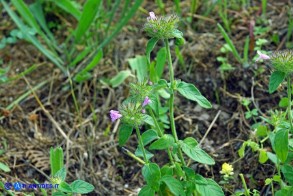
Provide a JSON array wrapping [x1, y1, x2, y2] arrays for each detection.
[[164, 39, 186, 166]]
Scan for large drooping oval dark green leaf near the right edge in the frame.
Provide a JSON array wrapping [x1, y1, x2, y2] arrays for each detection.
[[274, 129, 289, 163]]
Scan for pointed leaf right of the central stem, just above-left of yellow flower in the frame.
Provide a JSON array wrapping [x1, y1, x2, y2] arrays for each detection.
[[179, 141, 215, 165]]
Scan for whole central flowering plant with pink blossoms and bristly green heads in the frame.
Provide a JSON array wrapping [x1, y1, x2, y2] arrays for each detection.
[[110, 12, 224, 196]]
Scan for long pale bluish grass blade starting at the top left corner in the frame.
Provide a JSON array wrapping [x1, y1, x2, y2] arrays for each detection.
[[1, 0, 66, 73]]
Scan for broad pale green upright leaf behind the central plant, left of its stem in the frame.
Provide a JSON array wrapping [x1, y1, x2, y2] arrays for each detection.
[[128, 55, 148, 82]]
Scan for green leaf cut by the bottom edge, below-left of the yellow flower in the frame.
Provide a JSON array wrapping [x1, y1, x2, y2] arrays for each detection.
[[195, 179, 224, 196]]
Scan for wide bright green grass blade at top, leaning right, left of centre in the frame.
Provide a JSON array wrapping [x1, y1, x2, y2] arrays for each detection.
[[74, 0, 102, 43]]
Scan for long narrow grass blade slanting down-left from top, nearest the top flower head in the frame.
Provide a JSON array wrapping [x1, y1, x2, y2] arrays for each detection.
[[86, 0, 143, 64]]
